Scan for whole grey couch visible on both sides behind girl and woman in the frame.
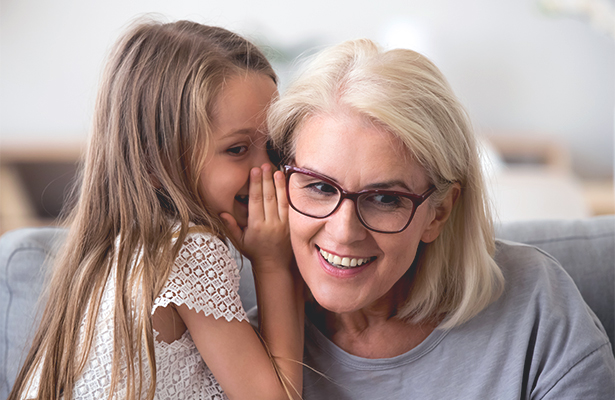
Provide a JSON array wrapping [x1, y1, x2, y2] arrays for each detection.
[[0, 216, 615, 399]]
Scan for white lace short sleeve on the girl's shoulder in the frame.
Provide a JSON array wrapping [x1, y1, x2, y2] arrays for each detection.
[[152, 232, 248, 321]]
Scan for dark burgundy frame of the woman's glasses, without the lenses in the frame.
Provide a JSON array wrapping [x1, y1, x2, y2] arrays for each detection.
[[284, 165, 436, 233]]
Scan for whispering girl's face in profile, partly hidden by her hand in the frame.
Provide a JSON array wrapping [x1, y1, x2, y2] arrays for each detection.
[[199, 72, 277, 228]]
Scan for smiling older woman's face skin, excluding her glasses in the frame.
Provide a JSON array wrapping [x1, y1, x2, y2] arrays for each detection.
[[289, 114, 446, 314]]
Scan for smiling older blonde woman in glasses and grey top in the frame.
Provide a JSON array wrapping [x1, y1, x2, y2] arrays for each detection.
[[269, 40, 615, 400]]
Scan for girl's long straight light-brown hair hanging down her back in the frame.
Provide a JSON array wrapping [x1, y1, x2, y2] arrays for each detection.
[[9, 17, 277, 400]]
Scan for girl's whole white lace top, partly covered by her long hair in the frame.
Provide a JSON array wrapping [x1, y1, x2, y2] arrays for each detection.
[[27, 229, 248, 399]]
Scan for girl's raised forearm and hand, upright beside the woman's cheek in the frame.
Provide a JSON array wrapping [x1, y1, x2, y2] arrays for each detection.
[[244, 164, 304, 398]]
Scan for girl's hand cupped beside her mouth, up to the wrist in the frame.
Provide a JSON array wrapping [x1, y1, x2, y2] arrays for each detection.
[[220, 164, 292, 269]]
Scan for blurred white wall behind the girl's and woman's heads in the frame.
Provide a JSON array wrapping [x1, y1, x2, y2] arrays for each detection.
[[0, 0, 615, 177]]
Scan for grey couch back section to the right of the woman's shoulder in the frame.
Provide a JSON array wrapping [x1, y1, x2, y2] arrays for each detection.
[[496, 215, 615, 352]]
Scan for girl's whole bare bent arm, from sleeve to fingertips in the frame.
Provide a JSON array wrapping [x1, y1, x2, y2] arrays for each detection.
[[176, 165, 303, 399]]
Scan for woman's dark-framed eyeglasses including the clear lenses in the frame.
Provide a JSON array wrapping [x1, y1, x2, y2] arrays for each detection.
[[284, 165, 436, 233]]
